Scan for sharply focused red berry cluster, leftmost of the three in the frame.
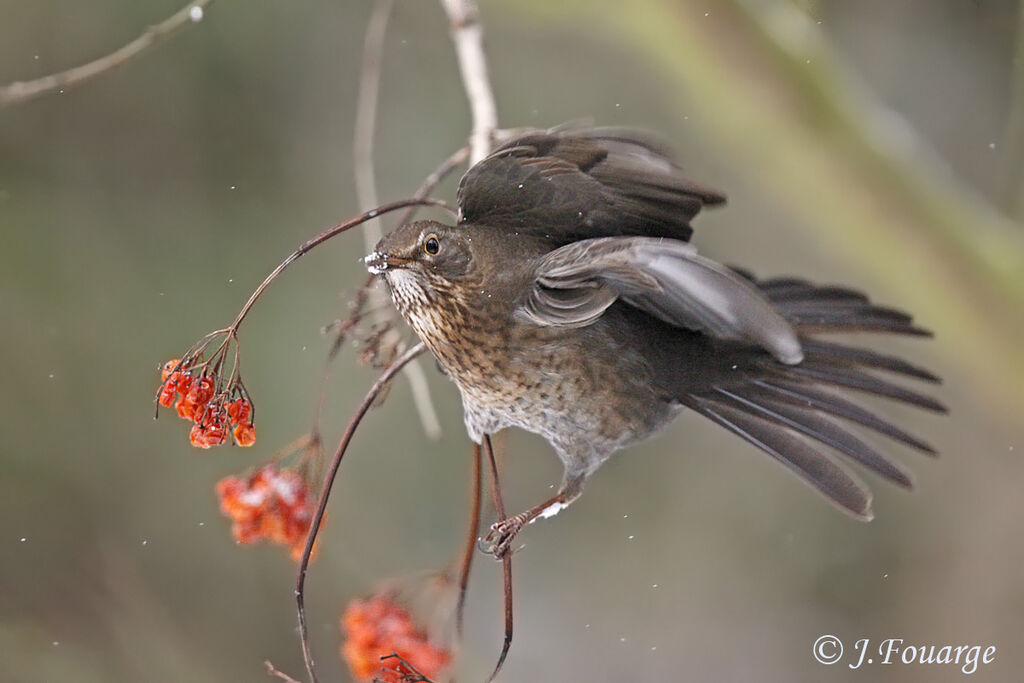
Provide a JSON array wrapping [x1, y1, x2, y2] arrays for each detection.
[[157, 359, 256, 449]]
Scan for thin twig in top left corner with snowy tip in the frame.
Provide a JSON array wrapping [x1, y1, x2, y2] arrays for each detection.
[[0, 0, 213, 108]]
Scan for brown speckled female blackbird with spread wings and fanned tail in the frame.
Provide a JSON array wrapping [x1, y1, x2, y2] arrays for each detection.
[[366, 129, 945, 556]]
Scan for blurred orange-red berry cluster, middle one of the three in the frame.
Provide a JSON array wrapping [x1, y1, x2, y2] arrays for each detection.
[[216, 464, 313, 560]]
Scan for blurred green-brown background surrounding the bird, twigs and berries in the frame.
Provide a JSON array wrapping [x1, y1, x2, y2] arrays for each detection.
[[0, 0, 1024, 683]]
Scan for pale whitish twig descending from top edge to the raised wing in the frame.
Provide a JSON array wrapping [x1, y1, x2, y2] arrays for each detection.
[[441, 0, 498, 166]]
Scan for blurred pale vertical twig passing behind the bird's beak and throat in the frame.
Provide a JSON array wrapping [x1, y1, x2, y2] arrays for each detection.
[[352, 0, 441, 439]]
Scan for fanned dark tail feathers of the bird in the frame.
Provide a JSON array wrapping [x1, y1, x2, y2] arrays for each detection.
[[682, 270, 946, 519]]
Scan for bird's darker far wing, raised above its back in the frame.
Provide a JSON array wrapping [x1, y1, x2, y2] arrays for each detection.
[[459, 128, 725, 244]]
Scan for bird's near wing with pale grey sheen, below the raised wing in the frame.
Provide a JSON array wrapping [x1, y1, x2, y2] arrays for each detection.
[[518, 238, 803, 365]]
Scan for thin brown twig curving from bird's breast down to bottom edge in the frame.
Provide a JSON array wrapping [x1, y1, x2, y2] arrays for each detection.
[[295, 342, 427, 683]]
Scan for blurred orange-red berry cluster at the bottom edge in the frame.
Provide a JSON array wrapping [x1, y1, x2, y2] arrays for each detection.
[[341, 594, 452, 683]]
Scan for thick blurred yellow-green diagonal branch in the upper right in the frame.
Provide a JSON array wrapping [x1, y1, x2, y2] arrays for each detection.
[[731, 0, 1024, 306]]
